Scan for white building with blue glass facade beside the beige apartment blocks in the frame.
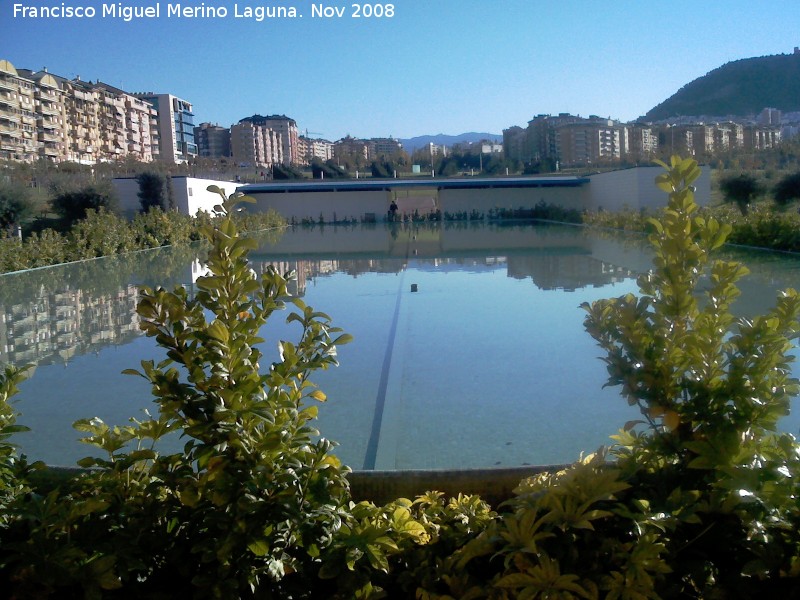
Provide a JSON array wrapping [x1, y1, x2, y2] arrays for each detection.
[[133, 92, 197, 164]]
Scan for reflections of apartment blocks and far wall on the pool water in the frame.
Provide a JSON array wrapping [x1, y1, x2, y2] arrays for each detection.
[[0, 223, 633, 365]]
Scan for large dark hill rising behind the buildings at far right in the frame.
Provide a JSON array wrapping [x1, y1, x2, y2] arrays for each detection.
[[645, 52, 800, 121]]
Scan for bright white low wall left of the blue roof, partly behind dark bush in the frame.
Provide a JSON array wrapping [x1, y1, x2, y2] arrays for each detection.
[[113, 176, 241, 218]]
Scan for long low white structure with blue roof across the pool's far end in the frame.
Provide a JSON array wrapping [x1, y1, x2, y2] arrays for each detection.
[[114, 166, 711, 223]]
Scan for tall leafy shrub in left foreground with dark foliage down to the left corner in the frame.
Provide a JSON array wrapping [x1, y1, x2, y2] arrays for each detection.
[[0, 189, 349, 598]]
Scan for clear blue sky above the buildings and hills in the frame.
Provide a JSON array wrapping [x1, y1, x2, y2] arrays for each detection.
[[0, 0, 800, 140]]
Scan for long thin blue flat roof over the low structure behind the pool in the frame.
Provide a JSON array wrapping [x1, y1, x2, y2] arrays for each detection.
[[237, 176, 589, 194]]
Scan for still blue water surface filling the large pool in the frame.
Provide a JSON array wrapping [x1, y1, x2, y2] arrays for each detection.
[[0, 224, 800, 469]]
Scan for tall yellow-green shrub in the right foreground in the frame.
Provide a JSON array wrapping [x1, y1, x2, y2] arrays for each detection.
[[585, 158, 800, 597]]
